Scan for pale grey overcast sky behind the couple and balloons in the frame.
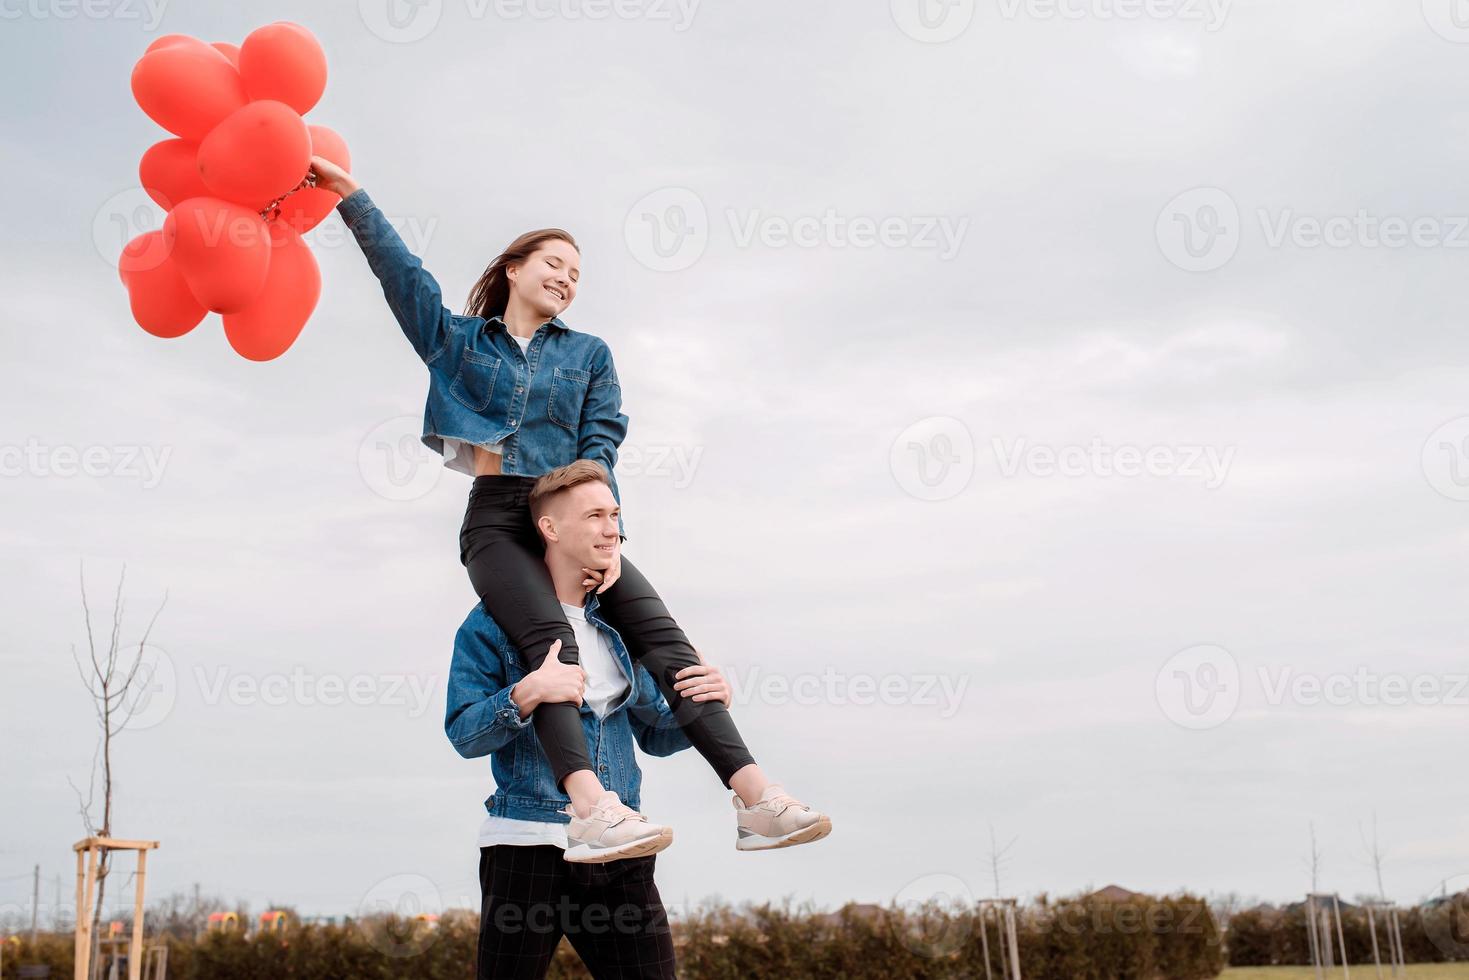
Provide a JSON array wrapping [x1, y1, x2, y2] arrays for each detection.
[[0, 0, 1469, 934]]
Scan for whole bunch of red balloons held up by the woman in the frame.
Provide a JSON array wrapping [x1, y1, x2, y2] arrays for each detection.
[[118, 21, 351, 361]]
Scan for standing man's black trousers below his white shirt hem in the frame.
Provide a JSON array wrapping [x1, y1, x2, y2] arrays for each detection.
[[474, 846, 674, 980]]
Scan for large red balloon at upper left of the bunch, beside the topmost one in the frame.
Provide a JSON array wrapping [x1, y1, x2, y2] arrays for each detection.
[[132, 35, 247, 141]]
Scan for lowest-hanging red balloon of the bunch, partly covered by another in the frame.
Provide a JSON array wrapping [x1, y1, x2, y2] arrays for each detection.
[[223, 222, 322, 360]]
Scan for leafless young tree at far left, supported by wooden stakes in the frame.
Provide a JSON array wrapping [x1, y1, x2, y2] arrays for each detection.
[[72, 566, 167, 962]]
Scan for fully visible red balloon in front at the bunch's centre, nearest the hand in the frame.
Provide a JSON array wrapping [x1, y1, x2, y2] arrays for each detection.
[[198, 100, 311, 210]]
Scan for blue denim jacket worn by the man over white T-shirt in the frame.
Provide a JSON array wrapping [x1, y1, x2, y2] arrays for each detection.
[[444, 592, 692, 823]]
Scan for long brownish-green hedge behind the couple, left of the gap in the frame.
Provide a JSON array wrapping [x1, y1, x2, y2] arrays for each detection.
[[3, 895, 1222, 980]]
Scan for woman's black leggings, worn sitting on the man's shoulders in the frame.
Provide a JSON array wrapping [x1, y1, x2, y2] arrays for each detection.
[[460, 476, 755, 788]]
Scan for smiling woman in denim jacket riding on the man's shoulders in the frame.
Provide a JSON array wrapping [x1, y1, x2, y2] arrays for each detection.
[[311, 157, 831, 851]]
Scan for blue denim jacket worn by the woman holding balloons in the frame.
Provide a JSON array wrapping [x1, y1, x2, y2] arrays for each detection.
[[336, 188, 627, 538]]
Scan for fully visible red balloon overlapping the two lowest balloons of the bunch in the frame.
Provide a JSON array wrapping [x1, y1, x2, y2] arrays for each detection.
[[163, 197, 270, 313]]
